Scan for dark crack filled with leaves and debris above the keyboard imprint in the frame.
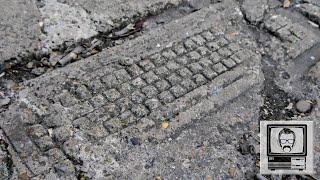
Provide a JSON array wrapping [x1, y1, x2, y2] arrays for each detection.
[[0, 1, 195, 83]]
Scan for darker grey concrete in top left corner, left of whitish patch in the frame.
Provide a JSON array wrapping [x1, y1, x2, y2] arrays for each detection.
[[0, 0, 40, 66]]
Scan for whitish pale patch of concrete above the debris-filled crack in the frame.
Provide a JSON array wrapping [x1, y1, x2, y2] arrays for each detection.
[[39, 0, 97, 51]]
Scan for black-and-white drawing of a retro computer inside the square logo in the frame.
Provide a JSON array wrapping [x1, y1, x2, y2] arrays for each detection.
[[267, 124, 308, 171]]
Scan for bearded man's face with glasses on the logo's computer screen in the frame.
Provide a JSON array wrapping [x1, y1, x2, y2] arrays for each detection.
[[279, 128, 296, 152]]
